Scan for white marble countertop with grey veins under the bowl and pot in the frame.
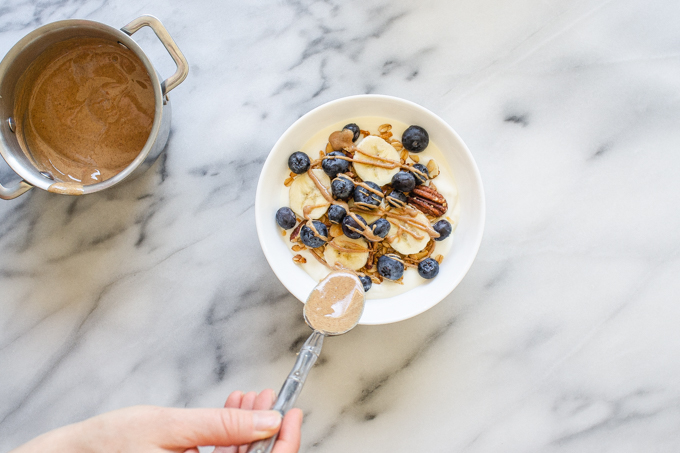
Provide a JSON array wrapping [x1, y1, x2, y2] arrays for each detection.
[[0, 0, 680, 453]]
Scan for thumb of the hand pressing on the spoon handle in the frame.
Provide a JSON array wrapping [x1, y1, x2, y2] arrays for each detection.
[[159, 409, 281, 448]]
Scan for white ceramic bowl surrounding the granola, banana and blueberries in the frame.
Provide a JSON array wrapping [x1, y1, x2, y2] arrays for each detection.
[[255, 95, 485, 324]]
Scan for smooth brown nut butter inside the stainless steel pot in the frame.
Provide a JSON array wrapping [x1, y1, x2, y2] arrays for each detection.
[[14, 37, 155, 190]]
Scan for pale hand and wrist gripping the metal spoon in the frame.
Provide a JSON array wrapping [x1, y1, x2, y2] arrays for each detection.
[[10, 389, 302, 453]]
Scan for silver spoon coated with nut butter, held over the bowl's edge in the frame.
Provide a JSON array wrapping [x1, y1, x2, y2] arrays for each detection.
[[248, 270, 366, 453]]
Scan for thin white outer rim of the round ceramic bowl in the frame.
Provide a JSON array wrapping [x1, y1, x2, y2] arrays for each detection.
[[254, 94, 486, 325]]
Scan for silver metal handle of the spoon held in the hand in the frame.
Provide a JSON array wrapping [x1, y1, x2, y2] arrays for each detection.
[[248, 330, 323, 453]]
